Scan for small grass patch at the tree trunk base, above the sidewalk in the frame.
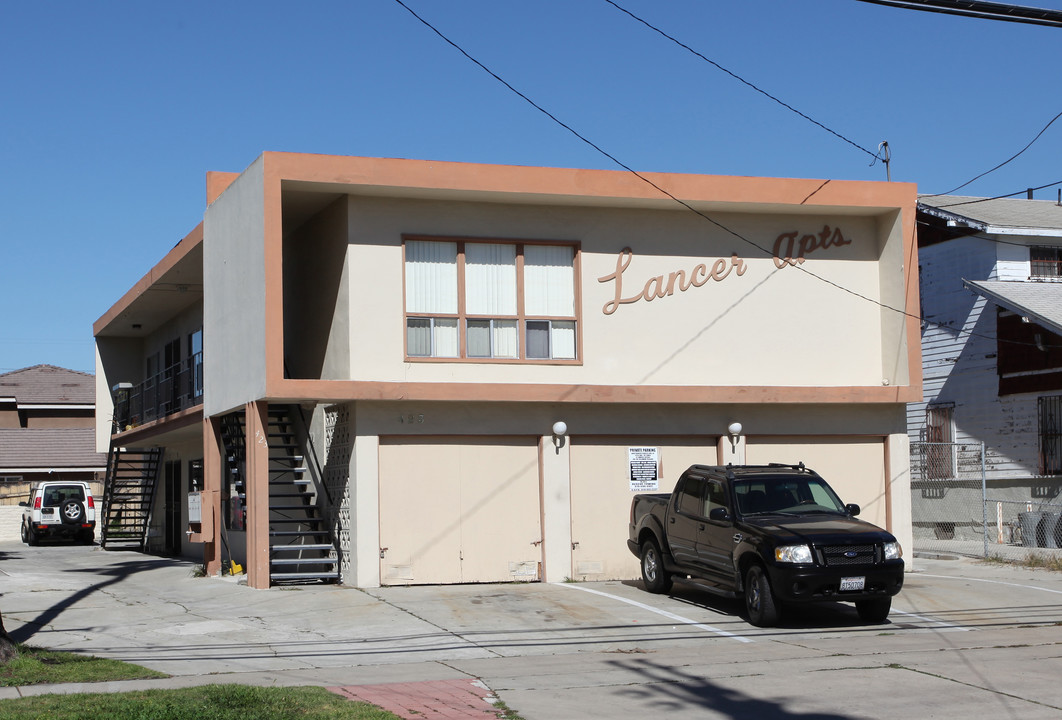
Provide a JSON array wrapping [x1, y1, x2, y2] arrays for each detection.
[[0, 645, 169, 687]]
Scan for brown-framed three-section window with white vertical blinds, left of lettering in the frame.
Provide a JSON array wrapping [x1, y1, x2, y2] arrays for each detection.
[[404, 237, 579, 362]]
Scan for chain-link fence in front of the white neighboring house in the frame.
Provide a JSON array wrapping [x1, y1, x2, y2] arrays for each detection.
[[911, 443, 1062, 559]]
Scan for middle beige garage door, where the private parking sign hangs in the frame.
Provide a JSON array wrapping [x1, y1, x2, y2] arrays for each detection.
[[570, 435, 718, 580]]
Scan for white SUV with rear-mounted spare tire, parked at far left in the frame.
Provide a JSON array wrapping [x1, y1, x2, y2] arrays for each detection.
[[18, 481, 96, 545]]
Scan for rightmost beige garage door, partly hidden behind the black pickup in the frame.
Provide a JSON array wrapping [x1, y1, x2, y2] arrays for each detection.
[[746, 436, 886, 528]]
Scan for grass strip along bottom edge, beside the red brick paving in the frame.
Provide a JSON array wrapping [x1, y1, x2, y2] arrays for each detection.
[[0, 685, 398, 720]]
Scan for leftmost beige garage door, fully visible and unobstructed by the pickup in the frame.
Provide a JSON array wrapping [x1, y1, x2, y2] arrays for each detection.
[[380, 438, 542, 585]]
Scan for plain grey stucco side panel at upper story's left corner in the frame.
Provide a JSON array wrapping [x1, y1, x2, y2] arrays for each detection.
[[203, 158, 269, 415]]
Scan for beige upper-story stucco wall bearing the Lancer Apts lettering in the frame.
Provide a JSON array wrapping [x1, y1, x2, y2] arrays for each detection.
[[347, 198, 908, 387]]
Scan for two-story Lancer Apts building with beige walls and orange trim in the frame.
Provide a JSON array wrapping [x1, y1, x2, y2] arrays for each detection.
[[95, 153, 921, 587]]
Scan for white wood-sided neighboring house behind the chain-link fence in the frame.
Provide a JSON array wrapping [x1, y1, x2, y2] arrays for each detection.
[[908, 195, 1062, 539]]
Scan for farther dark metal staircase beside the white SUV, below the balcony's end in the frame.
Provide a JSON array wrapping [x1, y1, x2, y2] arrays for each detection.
[[100, 443, 162, 552]]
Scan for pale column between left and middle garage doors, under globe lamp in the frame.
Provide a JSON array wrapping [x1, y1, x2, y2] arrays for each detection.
[[538, 435, 575, 583]]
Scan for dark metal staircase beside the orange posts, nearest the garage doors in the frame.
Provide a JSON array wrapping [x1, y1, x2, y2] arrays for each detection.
[[221, 406, 339, 584]]
